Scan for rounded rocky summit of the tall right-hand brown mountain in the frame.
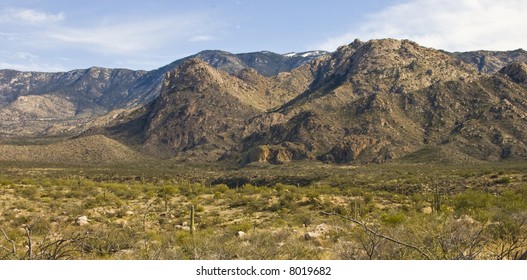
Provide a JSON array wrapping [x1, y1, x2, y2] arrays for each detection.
[[311, 39, 476, 98]]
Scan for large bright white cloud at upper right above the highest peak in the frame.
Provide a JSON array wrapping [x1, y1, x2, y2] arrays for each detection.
[[315, 0, 527, 51]]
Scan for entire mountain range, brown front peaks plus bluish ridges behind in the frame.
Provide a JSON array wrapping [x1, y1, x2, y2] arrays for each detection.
[[0, 39, 527, 165]]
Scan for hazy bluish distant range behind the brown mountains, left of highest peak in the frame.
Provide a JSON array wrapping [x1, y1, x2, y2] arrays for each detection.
[[0, 51, 326, 137]]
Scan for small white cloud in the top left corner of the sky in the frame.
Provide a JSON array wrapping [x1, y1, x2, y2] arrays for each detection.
[[0, 8, 65, 25]]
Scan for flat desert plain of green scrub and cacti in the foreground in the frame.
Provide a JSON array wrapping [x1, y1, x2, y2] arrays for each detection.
[[0, 162, 527, 259]]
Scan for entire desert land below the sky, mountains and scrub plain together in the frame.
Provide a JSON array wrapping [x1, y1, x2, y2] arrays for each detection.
[[0, 39, 527, 260]]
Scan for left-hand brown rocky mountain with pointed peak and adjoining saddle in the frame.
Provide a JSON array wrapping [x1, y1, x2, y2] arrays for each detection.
[[98, 58, 322, 160]]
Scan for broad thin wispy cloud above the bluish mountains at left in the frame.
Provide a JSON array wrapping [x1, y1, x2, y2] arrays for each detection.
[[0, 5, 225, 71]]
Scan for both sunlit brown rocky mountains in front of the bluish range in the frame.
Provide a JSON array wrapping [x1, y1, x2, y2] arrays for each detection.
[[92, 39, 527, 165]]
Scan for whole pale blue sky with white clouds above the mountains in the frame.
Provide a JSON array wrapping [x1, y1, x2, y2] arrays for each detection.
[[0, 0, 527, 71]]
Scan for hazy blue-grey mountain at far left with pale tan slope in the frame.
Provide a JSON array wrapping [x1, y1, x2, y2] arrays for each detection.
[[0, 67, 156, 136]]
